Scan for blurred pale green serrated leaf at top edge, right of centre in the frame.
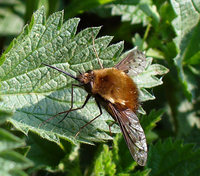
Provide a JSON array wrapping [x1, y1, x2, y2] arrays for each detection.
[[111, 0, 160, 25]]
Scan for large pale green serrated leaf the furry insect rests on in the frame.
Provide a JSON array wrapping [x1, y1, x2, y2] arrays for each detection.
[[0, 8, 166, 143]]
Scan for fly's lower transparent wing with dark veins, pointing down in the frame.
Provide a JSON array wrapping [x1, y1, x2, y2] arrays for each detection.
[[109, 103, 147, 166]]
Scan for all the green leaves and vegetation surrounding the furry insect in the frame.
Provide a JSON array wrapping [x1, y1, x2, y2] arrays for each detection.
[[0, 0, 200, 176]]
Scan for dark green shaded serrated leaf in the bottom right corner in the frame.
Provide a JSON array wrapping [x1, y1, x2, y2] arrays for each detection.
[[147, 139, 200, 176]]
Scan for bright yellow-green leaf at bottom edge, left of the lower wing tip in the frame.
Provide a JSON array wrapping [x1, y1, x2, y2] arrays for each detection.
[[91, 134, 150, 176]]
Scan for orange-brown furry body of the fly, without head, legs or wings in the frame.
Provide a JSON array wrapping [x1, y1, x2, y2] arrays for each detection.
[[92, 68, 138, 112]]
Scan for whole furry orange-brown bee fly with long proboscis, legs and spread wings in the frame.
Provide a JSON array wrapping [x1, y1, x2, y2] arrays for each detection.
[[41, 44, 147, 166]]
